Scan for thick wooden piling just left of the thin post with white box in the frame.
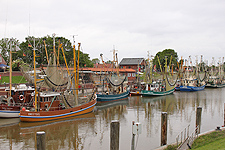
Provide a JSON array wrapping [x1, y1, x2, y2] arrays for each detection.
[[110, 120, 120, 150]]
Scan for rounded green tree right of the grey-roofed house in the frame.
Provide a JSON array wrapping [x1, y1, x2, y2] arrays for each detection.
[[153, 49, 178, 71]]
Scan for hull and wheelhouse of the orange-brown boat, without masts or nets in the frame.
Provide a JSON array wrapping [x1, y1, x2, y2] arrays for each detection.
[[20, 93, 96, 122]]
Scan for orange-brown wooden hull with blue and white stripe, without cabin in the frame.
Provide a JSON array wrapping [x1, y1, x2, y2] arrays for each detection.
[[19, 99, 96, 122]]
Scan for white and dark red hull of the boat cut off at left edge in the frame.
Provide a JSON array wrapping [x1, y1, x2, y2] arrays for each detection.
[[0, 105, 20, 118]]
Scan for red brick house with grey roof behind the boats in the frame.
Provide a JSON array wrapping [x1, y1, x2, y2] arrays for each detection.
[[119, 58, 146, 72]]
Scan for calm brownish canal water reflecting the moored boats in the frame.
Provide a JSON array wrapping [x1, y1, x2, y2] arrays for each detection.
[[0, 88, 225, 150]]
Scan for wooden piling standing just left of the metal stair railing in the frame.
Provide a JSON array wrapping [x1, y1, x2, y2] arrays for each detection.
[[161, 112, 167, 146]]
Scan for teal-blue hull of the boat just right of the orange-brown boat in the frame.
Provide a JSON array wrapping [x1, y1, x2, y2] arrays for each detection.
[[97, 91, 130, 103]]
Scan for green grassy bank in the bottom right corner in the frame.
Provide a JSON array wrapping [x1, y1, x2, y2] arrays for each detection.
[[191, 130, 225, 150]]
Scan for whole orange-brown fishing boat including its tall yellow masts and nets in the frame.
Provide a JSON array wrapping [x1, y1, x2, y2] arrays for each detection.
[[19, 36, 96, 122]]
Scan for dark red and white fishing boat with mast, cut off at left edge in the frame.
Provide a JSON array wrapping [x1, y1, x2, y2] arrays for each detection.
[[0, 39, 34, 118]]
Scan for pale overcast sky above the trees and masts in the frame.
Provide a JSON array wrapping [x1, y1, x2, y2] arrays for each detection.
[[0, 0, 225, 62]]
